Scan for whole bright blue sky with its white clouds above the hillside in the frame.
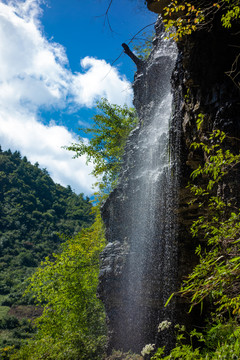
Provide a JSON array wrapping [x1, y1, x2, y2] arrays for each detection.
[[0, 0, 156, 195]]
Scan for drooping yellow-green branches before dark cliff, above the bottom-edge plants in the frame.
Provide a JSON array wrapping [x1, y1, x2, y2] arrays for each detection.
[[180, 126, 240, 315]]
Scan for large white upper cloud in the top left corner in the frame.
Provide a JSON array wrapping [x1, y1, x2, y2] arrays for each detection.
[[0, 0, 71, 110]]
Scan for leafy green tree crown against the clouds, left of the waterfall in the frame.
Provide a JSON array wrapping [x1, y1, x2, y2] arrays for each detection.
[[67, 99, 137, 192]]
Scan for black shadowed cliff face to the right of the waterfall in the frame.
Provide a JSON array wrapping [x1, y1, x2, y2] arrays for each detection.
[[172, 15, 240, 246]]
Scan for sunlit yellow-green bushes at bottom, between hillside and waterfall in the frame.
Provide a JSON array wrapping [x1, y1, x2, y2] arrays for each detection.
[[11, 210, 105, 360]]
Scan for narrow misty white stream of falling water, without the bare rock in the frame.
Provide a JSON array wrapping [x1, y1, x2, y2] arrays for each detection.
[[120, 30, 176, 351]]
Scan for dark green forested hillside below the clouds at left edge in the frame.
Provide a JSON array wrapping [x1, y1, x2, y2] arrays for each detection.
[[0, 149, 93, 348]]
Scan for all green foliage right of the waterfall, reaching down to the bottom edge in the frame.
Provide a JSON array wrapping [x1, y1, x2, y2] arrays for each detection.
[[152, 122, 240, 360]]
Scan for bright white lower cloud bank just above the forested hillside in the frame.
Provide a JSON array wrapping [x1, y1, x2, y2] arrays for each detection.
[[0, 110, 96, 194]]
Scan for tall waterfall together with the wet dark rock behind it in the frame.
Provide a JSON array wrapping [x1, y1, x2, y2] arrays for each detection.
[[100, 19, 177, 353]]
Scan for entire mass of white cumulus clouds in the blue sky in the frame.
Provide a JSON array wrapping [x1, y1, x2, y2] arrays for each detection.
[[0, 0, 132, 194]]
